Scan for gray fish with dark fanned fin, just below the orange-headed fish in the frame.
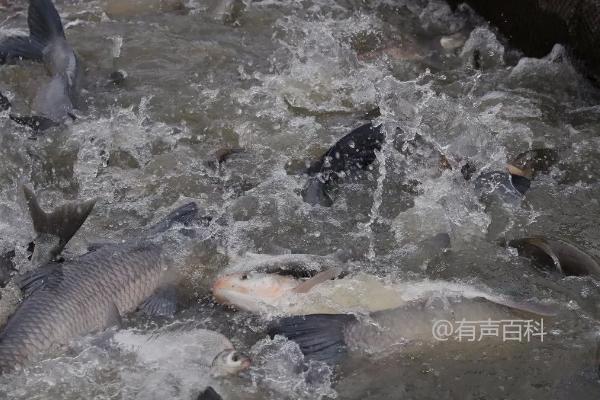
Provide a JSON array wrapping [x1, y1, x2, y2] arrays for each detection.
[[269, 298, 555, 364]]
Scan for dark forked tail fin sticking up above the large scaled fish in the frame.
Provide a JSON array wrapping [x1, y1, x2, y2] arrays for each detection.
[[23, 185, 96, 262]]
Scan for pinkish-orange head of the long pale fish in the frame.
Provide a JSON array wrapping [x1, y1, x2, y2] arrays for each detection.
[[212, 272, 298, 312]]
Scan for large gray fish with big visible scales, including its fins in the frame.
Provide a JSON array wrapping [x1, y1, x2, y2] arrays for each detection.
[[0, 198, 204, 373]]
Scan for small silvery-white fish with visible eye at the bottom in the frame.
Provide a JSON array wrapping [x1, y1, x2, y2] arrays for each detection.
[[112, 321, 251, 377]]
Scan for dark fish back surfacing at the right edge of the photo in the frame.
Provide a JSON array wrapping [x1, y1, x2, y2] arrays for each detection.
[[508, 237, 600, 279]]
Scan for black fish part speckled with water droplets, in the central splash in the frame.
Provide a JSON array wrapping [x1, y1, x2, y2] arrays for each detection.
[[302, 123, 385, 207]]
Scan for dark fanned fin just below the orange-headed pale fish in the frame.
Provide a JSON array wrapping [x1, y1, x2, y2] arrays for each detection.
[[268, 314, 356, 364]]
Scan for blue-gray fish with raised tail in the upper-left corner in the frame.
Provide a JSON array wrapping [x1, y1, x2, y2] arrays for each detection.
[[0, 0, 82, 130]]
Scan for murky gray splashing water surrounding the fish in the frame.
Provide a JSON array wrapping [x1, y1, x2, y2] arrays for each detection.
[[0, 0, 600, 399]]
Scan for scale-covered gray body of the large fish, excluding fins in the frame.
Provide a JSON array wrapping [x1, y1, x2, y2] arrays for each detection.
[[0, 244, 164, 372]]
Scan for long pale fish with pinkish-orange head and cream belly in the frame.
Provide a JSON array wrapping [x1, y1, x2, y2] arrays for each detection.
[[212, 268, 546, 317]]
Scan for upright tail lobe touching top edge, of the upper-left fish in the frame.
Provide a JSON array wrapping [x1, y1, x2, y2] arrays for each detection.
[[27, 0, 65, 47]]
